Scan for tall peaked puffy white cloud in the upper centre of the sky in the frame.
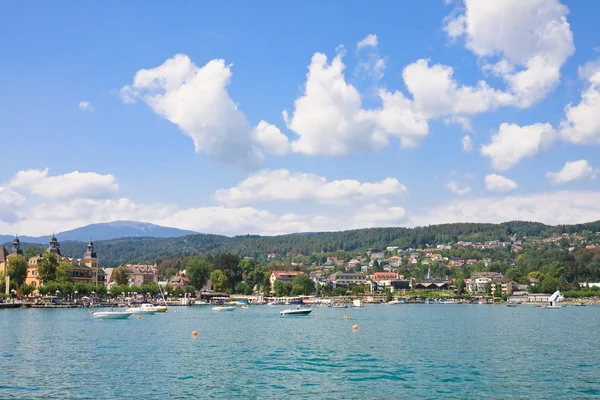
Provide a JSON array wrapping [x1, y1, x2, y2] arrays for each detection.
[[283, 49, 429, 156]]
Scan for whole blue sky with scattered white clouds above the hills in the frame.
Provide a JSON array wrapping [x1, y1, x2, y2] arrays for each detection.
[[0, 0, 600, 235]]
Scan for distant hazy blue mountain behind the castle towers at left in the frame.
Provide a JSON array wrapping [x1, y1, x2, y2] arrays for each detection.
[[0, 221, 197, 245]]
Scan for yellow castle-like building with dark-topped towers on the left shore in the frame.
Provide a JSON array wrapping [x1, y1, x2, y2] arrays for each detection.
[[25, 234, 99, 287]]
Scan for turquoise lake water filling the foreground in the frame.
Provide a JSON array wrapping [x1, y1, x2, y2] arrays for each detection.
[[0, 304, 600, 399]]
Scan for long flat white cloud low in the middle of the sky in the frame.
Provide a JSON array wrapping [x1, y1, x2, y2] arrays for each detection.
[[215, 169, 406, 206]]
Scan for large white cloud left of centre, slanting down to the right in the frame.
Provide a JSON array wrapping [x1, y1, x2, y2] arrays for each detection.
[[121, 54, 282, 168]]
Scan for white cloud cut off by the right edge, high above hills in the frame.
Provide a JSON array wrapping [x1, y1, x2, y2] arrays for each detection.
[[560, 61, 600, 144]]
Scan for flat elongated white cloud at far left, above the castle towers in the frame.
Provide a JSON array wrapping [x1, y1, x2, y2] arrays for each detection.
[[9, 168, 119, 198]]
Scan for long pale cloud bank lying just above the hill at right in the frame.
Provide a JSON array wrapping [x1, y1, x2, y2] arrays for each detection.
[[409, 191, 600, 226]]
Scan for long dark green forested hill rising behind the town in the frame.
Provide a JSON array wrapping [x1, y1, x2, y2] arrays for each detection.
[[12, 221, 600, 267]]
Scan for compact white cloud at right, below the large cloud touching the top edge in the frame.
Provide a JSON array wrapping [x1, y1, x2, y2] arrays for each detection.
[[481, 123, 556, 171]]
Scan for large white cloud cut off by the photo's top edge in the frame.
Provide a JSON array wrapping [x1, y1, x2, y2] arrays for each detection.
[[445, 0, 575, 107]]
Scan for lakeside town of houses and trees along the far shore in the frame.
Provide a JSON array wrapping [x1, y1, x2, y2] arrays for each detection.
[[0, 228, 600, 303]]
